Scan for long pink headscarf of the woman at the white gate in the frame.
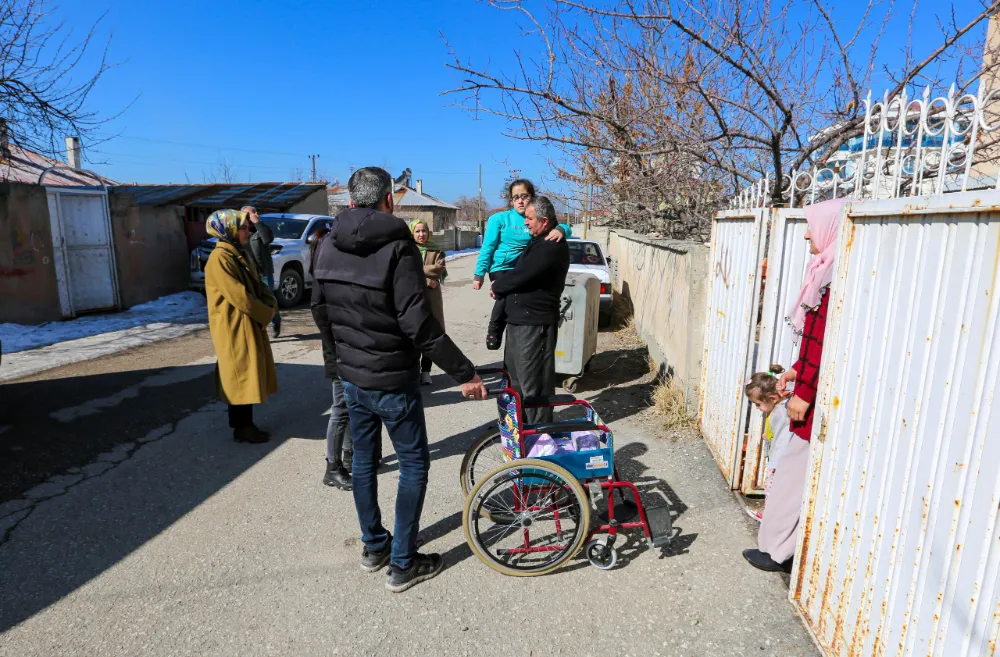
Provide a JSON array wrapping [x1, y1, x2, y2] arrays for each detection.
[[786, 198, 853, 335]]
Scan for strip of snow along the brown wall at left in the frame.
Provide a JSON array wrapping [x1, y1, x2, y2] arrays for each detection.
[[0, 292, 208, 354]]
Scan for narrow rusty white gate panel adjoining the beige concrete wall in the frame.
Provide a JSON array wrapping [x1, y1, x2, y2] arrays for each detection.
[[699, 208, 769, 488]]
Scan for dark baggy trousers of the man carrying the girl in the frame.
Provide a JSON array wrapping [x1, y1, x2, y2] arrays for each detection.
[[504, 324, 559, 425]]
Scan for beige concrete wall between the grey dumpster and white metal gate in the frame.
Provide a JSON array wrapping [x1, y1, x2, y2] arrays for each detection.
[[608, 231, 709, 412]]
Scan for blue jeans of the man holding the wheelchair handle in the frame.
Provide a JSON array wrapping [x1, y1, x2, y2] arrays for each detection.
[[344, 381, 431, 570]]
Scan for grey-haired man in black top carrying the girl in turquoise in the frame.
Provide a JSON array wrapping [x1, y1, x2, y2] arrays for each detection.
[[490, 196, 569, 425]]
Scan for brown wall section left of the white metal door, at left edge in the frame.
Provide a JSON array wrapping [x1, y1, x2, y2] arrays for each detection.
[[0, 183, 62, 324]]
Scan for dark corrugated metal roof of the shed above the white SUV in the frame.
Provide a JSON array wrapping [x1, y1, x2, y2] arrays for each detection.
[[112, 182, 326, 210]]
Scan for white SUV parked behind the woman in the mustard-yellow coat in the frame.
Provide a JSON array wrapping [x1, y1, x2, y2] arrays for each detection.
[[191, 214, 333, 308]]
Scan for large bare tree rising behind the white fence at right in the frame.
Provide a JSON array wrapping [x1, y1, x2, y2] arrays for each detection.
[[445, 0, 1000, 238]]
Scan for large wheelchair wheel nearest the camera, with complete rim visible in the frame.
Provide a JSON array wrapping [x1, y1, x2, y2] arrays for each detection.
[[462, 459, 590, 577]]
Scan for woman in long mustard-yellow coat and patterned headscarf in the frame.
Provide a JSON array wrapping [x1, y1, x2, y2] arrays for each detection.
[[205, 210, 278, 443]]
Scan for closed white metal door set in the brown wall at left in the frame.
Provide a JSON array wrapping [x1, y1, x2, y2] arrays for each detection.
[[46, 186, 119, 317]]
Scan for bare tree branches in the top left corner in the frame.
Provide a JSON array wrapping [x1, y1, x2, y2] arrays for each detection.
[[0, 0, 113, 169]]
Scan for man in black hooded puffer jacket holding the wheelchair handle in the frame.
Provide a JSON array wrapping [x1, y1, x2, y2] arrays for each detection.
[[314, 167, 486, 592]]
